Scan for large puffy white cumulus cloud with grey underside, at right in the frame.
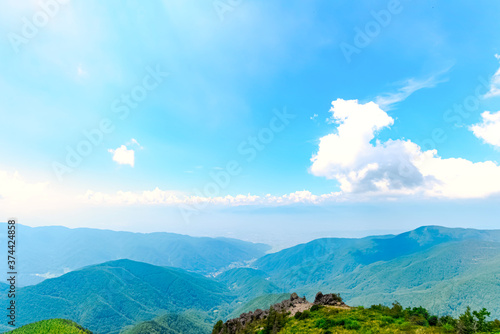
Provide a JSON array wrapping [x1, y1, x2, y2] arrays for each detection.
[[310, 99, 500, 198]]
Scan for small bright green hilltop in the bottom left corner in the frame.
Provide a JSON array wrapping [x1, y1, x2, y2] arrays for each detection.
[[7, 319, 92, 334]]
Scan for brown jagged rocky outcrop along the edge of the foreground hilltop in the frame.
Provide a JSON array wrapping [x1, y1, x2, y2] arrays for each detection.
[[212, 292, 347, 334]]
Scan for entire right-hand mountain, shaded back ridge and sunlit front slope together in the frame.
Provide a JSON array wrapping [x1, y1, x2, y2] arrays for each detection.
[[256, 226, 500, 317]]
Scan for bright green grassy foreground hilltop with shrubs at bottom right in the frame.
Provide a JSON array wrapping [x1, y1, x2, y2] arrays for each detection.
[[212, 295, 500, 334]]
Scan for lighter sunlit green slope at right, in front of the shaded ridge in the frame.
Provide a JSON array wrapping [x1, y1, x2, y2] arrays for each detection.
[[340, 242, 500, 317]]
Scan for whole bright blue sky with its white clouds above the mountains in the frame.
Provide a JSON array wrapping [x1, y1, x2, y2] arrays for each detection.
[[0, 0, 500, 243]]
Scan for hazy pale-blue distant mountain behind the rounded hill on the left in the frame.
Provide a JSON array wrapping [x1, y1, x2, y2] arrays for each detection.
[[0, 224, 270, 286]]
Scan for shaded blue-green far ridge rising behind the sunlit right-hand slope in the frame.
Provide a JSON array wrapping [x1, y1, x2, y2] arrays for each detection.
[[255, 226, 500, 290]]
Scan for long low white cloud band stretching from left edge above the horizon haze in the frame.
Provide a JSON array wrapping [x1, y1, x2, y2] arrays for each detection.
[[0, 171, 344, 213]]
